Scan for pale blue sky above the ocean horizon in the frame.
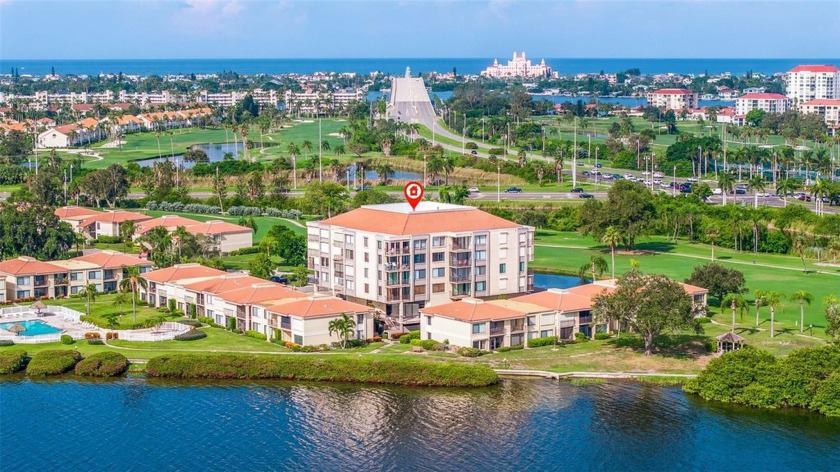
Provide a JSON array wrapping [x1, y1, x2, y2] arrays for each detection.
[[0, 0, 840, 59]]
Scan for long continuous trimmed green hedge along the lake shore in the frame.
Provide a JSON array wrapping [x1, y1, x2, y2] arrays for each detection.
[[146, 354, 499, 387]]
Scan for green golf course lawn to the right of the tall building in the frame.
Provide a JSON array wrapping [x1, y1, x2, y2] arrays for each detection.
[[532, 230, 840, 337]]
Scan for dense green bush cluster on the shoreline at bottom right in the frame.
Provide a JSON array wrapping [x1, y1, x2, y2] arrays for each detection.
[[684, 346, 840, 416]]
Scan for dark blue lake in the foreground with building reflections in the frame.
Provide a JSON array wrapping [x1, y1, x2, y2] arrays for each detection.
[[0, 376, 840, 472]]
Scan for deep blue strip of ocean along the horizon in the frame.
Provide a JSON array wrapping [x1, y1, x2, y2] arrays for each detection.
[[0, 54, 840, 75]]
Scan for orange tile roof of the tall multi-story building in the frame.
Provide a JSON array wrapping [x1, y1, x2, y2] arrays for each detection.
[[320, 202, 521, 235]]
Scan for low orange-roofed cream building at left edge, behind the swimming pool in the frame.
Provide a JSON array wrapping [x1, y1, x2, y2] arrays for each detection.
[[0, 251, 152, 301]]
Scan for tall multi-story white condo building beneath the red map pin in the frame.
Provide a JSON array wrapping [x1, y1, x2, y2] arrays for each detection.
[[307, 201, 534, 326]]
